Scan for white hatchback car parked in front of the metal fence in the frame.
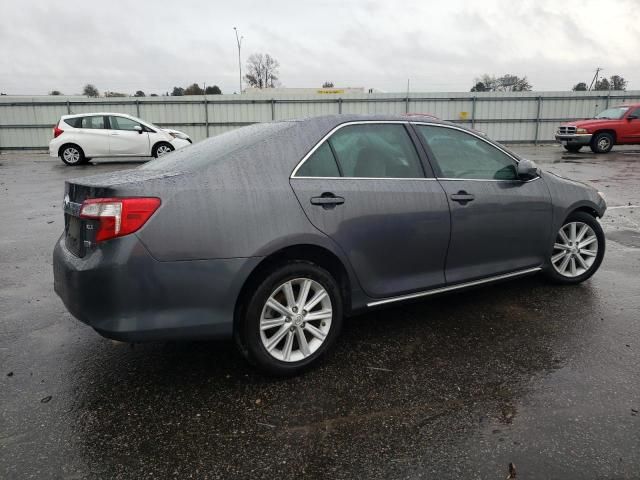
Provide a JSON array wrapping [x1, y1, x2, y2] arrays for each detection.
[[49, 112, 192, 165]]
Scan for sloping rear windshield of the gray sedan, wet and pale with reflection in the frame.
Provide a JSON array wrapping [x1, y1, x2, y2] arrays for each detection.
[[139, 122, 293, 171]]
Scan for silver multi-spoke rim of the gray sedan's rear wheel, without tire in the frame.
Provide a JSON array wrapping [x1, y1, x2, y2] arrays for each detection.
[[260, 278, 333, 362]]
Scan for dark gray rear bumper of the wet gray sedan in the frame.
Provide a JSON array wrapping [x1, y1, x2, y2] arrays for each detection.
[[53, 235, 261, 342]]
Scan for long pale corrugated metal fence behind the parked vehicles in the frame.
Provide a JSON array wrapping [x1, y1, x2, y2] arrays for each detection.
[[0, 91, 640, 150]]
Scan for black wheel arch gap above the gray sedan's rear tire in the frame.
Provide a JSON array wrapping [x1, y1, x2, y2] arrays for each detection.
[[233, 243, 352, 338]]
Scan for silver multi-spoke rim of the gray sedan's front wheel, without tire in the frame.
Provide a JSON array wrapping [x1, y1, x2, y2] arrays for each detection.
[[551, 222, 598, 278]]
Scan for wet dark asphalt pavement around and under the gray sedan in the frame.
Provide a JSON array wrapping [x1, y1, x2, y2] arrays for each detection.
[[0, 146, 640, 479]]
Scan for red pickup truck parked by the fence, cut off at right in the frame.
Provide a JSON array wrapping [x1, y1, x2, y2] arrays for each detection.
[[556, 104, 640, 153]]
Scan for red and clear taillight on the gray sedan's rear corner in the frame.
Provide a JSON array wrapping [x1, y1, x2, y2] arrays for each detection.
[[80, 197, 160, 242]]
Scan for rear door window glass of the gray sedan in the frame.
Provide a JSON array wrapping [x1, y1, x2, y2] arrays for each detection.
[[329, 124, 424, 178]]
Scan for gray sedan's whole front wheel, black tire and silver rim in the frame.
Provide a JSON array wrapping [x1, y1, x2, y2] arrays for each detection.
[[547, 212, 605, 283]]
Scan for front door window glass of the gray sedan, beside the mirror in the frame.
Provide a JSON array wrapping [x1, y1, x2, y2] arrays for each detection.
[[417, 125, 518, 180]]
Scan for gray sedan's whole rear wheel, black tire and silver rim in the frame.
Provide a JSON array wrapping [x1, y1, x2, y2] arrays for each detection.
[[240, 261, 342, 375]]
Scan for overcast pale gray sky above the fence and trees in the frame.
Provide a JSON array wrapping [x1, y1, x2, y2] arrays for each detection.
[[0, 0, 640, 95]]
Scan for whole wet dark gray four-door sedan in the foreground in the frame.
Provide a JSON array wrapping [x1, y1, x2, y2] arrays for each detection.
[[54, 115, 606, 375]]
